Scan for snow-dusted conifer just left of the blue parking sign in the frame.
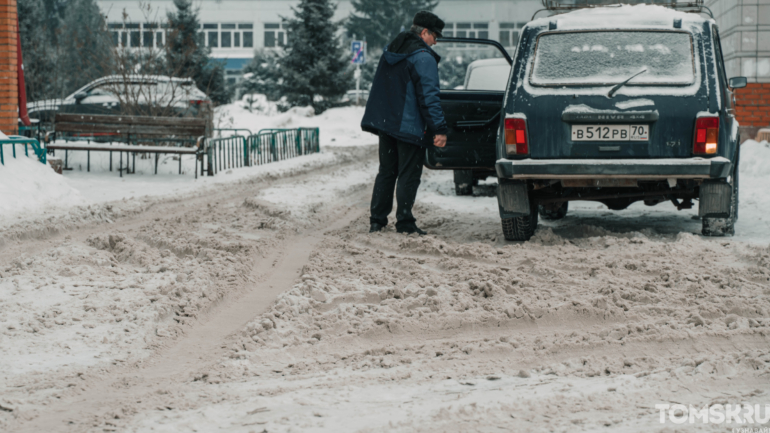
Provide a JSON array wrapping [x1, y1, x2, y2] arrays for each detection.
[[280, 0, 353, 113]]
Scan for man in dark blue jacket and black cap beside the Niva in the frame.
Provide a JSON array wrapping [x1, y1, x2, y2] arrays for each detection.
[[361, 12, 447, 235]]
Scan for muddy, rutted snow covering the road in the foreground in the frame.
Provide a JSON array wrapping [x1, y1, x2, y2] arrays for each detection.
[[0, 106, 770, 432]]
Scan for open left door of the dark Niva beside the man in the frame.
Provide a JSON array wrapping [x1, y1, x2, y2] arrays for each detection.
[[425, 38, 513, 195]]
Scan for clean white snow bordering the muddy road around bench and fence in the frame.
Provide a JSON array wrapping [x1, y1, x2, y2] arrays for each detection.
[[0, 103, 377, 228]]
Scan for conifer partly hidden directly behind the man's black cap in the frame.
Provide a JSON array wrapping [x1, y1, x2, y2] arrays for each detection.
[[345, 0, 438, 51]]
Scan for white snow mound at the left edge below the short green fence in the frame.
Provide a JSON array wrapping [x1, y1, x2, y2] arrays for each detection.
[[0, 145, 87, 220]]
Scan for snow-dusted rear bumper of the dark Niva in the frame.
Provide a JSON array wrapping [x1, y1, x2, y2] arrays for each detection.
[[495, 156, 732, 179]]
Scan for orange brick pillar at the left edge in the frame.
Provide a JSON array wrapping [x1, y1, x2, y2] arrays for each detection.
[[0, 0, 19, 134]]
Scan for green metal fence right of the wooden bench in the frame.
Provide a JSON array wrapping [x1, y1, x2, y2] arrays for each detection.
[[200, 128, 320, 176]]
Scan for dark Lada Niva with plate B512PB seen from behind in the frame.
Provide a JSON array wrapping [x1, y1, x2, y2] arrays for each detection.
[[427, 5, 746, 241]]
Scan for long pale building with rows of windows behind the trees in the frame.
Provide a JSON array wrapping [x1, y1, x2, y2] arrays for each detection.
[[97, 0, 542, 83]]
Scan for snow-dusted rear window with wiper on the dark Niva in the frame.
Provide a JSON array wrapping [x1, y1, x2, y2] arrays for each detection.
[[529, 31, 695, 86]]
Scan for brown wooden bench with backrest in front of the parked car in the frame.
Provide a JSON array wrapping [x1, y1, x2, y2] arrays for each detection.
[[46, 113, 206, 178]]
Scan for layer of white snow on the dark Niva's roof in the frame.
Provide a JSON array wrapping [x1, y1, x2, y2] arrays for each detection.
[[527, 4, 713, 30]]
